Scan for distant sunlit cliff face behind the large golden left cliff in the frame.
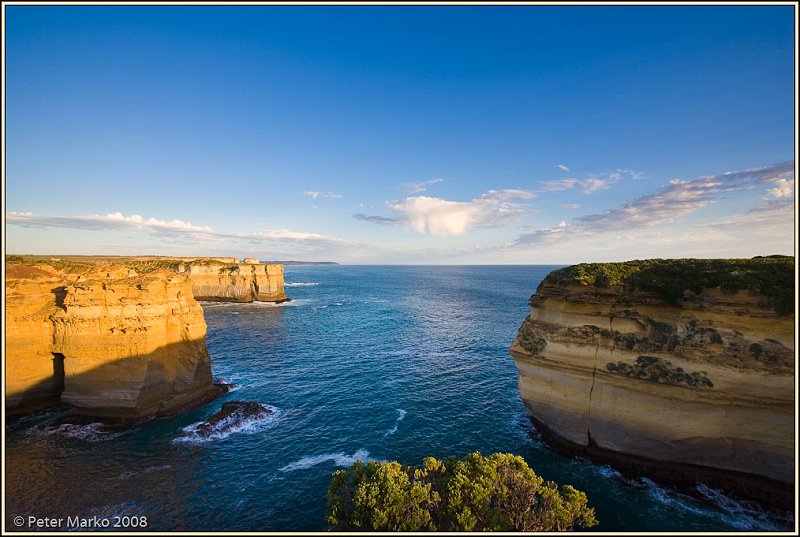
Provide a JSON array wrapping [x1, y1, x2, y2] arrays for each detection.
[[183, 260, 288, 302]]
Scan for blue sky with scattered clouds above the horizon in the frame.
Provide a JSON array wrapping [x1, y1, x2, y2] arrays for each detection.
[[3, 5, 796, 264]]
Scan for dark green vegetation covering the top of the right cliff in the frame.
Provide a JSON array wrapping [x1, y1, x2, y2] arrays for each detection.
[[543, 256, 795, 315]]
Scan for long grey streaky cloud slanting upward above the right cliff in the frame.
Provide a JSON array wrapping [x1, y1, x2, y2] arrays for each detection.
[[513, 162, 794, 245]]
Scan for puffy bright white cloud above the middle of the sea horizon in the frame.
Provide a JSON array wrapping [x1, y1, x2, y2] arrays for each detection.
[[354, 189, 535, 237]]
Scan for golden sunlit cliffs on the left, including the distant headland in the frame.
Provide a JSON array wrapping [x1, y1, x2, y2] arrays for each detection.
[[5, 256, 287, 423]]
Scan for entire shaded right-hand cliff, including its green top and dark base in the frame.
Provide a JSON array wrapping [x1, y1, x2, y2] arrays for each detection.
[[510, 257, 795, 510]]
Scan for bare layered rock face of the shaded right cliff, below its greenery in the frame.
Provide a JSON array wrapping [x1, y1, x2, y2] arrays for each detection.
[[510, 262, 795, 500]]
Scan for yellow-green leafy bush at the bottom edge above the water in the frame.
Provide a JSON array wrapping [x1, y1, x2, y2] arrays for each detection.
[[326, 453, 597, 531]]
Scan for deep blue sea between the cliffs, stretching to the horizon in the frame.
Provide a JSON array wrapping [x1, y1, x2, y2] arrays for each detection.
[[5, 266, 793, 532]]
